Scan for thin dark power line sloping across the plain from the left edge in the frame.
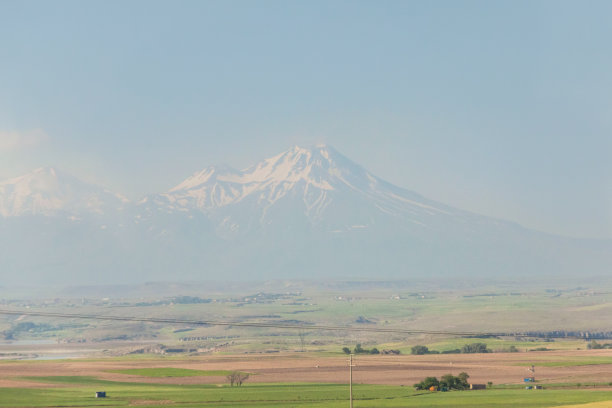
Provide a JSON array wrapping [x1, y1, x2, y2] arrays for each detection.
[[0, 309, 565, 337]]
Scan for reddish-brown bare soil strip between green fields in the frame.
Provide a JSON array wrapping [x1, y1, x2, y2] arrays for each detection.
[[0, 350, 612, 388]]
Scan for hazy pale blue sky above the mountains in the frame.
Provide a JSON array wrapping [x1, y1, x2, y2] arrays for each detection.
[[0, 0, 612, 238]]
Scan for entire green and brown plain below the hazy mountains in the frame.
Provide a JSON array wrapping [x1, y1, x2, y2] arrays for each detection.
[[0, 283, 612, 408]]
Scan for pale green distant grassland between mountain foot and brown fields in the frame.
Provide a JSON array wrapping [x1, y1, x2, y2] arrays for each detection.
[[5, 283, 612, 353]]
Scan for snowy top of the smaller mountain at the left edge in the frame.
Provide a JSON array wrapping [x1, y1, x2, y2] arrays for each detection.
[[0, 167, 128, 217]]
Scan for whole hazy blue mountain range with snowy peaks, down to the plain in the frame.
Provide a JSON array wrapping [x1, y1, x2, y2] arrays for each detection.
[[0, 146, 612, 283]]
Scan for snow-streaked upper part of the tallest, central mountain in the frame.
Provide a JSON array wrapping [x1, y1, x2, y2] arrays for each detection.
[[141, 145, 492, 236]]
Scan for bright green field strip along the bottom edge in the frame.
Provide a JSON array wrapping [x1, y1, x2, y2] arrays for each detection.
[[0, 376, 612, 408]]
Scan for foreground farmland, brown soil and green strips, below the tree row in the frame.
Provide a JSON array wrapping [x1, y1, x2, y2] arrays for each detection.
[[0, 350, 612, 407]]
